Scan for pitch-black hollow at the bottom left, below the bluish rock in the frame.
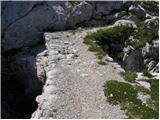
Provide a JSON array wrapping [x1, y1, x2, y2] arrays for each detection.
[[2, 78, 38, 119]]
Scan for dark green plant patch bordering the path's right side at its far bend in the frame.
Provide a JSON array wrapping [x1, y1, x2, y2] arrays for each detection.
[[84, 25, 133, 63]]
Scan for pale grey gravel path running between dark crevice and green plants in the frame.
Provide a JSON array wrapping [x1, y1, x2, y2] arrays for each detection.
[[32, 28, 126, 119]]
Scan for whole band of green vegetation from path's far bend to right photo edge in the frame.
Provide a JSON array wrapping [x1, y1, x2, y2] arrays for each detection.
[[84, 22, 158, 63]]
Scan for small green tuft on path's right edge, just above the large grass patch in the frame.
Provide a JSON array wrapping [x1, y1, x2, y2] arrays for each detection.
[[120, 71, 137, 83]]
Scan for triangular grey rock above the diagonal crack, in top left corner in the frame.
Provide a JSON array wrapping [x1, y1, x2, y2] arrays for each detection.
[[1, 1, 41, 32]]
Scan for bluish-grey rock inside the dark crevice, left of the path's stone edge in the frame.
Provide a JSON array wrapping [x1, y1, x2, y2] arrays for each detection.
[[11, 55, 42, 99]]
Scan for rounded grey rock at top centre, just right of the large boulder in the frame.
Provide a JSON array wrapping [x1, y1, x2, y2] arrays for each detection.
[[66, 2, 92, 27]]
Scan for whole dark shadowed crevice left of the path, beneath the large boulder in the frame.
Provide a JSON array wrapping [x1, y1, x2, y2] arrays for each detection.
[[1, 41, 46, 119]]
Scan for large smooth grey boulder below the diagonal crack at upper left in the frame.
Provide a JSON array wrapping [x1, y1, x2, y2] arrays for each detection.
[[2, 3, 66, 51]]
